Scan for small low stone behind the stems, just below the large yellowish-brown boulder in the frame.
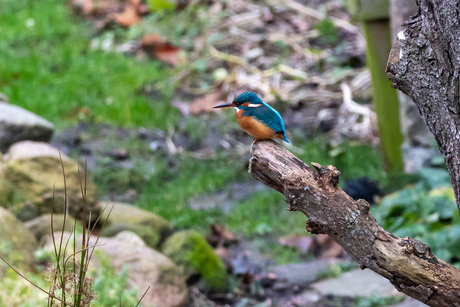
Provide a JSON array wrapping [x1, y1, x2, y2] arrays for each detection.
[[24, 213, 83, 241]]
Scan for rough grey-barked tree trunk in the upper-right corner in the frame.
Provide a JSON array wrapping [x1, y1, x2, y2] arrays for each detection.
[[386, 0, 460, 209]]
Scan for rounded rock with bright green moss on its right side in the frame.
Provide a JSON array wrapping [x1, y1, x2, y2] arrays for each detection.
[[161, 230, 228, 292]]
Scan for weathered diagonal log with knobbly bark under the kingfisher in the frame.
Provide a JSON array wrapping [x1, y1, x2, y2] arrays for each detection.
[[249, 141, 460, 307]]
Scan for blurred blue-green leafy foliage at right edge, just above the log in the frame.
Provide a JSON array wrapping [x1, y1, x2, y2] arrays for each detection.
[[371, 168, 460, 267]]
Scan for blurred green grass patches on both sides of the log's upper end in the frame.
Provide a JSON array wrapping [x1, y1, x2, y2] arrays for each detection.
[[139, 140, 388, 236]]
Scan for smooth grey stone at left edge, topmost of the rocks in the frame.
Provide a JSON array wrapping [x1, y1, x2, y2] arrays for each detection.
[[0, 103, 54, 152]]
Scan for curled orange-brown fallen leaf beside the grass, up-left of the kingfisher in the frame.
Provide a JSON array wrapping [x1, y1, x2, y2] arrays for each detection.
[[141, 34, 185, 66]]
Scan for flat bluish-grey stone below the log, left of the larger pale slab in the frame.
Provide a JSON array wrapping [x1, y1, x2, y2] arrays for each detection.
[[268, 259, 336, 290]]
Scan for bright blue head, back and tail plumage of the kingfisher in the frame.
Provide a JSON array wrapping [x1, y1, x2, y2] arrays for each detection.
[[233, 92, 289, 143]]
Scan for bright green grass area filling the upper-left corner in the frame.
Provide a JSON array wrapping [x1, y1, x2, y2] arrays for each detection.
[[0, 0, 179, 129]]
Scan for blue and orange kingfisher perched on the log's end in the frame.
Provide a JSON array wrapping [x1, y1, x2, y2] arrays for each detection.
[[213, 92, 289, 143]]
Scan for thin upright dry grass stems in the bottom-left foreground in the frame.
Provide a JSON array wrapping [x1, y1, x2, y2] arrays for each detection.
[[0, 158, 149, 307]]
